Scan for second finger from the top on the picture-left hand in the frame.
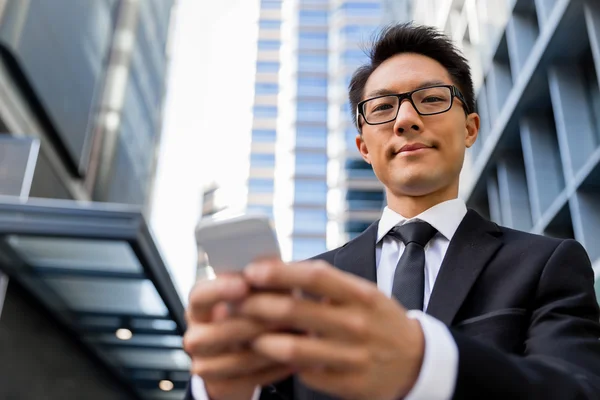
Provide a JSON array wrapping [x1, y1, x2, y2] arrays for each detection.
[[183, 318, 266, 356]]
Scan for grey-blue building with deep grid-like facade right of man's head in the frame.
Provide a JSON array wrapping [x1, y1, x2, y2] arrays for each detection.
[[415, 0, 600, 278]]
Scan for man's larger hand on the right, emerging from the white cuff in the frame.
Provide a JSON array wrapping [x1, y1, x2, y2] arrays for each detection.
[[238, 261, 424, 400]]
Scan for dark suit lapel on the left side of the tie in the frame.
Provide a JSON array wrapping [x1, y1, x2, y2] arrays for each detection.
[[333, 221, 379, 283]]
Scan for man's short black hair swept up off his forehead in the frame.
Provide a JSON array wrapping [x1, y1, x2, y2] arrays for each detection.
[[348, 23, 475, 131]]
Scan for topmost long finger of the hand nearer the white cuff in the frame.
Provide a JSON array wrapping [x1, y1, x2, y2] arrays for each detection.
[[244, 261, 379, 303]]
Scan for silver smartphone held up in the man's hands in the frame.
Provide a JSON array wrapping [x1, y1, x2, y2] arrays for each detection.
[[196, 215, 281, 274]]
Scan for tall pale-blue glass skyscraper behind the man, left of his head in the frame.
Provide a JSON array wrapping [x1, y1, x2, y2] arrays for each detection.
[[203, 0, 412, 260]]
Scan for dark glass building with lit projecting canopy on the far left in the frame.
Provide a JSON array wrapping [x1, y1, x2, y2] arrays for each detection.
[[0, 0, 178, 399]]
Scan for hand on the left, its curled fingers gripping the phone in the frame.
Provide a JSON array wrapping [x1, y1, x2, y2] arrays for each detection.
[[183, 275, 292, 400]]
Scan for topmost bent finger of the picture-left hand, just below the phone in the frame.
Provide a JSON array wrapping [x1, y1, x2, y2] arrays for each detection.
[[186, 275, 249, 322]]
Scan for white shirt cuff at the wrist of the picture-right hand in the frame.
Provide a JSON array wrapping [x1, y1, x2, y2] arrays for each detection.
[[405, 310, 458, 400]]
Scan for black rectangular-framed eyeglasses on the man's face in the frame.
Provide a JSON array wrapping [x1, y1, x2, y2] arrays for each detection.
[[357, 85, 468, 125]]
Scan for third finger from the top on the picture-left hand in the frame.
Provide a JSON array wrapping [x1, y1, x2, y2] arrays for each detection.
[[192, 350, 275, 379]]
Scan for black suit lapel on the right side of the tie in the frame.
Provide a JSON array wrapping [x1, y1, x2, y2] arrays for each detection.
[[427, 210, 502, 326]]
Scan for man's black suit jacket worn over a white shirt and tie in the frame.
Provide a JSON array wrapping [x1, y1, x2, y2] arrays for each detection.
[[185, 210, 600, 400]]
